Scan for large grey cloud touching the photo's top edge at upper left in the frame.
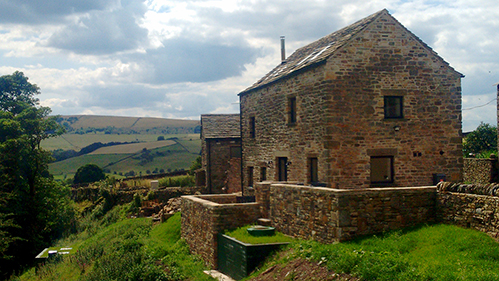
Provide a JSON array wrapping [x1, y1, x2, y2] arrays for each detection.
[[47, 0, 148, 55]]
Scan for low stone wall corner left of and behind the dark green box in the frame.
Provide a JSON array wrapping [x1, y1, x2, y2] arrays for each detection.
[[182, 195, 260, 268]]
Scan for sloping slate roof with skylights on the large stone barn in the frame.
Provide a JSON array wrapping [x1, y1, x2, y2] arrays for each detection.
[[239, 9, 464, 95]]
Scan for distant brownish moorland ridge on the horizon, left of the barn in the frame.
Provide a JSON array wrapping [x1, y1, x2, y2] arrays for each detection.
[[57, 115, 201, 134]]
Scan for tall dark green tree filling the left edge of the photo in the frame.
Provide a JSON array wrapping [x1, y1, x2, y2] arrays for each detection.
[[0, 71, 73, 279]]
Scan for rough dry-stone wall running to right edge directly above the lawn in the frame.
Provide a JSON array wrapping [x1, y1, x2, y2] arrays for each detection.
[[437, 191, 499, 239]]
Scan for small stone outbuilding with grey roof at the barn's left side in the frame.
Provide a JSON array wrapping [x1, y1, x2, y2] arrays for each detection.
[[201, 114, 241, 194]]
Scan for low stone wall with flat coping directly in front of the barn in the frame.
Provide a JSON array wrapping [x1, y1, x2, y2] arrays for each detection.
[[256, 183, 436, 243]]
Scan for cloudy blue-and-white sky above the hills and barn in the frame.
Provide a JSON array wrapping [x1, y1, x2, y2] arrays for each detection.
[[0, 0, 499, 132]]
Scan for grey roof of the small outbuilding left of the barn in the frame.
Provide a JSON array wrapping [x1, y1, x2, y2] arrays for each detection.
[[201, 114, 241, 139]]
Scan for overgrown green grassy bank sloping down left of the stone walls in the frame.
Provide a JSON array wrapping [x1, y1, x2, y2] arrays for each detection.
[[13, 209, 213, 281]]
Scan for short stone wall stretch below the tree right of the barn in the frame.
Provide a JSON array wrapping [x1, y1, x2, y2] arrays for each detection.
[[463, 158, 497, 184]]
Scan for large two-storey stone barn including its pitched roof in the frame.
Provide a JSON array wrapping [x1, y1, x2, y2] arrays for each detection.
[[239, 10, 463, 192]]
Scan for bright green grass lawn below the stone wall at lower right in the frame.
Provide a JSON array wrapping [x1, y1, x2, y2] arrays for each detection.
[[248, 224, 499, 281]]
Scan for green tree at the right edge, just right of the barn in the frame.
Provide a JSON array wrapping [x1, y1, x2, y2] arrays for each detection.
[[463, 122, 497, 157]]
